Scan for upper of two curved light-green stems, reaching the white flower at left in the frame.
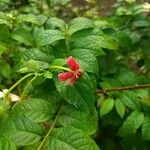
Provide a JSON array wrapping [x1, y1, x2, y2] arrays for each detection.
[[4, 73, 34, 98]]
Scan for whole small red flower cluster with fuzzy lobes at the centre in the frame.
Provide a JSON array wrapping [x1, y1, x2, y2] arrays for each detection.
[[58, 56, 82, 85]]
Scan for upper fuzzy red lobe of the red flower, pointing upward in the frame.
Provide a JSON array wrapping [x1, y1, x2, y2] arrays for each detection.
[[66, 56, 79, 71]]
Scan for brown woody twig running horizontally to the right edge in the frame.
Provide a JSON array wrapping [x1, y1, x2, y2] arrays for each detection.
[[96, 84, 150, 93]]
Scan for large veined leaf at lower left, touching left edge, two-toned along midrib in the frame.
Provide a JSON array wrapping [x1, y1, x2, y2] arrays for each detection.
[[0, 115, 43, 146]]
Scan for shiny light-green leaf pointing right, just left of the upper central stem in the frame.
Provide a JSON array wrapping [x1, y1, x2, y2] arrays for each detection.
[[36, 30, 64, 46]]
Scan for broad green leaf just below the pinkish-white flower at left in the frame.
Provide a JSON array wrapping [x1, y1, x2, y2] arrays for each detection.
[[13, 98, 52, 122]]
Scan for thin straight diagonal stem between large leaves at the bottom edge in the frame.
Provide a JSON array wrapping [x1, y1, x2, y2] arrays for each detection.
[[37, 106, 63, 150]]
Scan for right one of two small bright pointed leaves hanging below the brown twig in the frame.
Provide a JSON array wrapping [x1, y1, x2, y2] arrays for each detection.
[[115, 99, 126, 118]]
